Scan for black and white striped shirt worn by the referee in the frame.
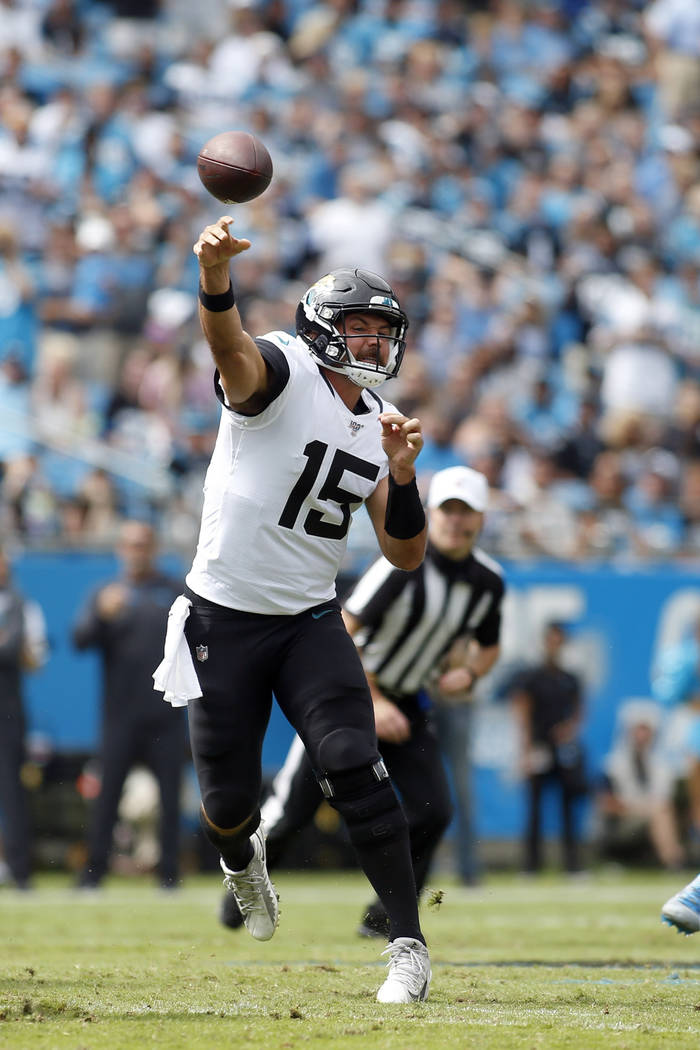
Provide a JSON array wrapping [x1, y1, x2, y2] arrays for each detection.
[[344, 544, 505, 696]]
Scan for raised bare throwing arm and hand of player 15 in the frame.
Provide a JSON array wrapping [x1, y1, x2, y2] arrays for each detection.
[[193, 215, 268, 405]]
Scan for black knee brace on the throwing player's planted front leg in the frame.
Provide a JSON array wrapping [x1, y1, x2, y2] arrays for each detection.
[[319, 758, 407, 845]]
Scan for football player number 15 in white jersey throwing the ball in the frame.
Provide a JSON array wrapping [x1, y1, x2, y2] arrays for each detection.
[[154, 215, 430, 1003]]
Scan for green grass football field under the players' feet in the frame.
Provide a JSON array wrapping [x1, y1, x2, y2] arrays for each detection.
[[0, 872, 700, 1050]]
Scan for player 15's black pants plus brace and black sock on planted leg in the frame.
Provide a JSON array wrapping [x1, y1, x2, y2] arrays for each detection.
[[185, 591, 422, 938]]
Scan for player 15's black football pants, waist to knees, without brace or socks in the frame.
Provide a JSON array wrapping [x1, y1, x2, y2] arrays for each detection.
[[185, 592, 379, 830]]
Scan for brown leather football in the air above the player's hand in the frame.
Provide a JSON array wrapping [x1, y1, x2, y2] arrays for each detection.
[[197, 131, 272, 204]]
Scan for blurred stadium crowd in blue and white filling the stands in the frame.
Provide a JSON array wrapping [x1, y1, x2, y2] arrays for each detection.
[[0, 0, 700, 562]]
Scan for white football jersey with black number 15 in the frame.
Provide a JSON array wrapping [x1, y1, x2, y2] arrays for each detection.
[[187, 332, 396, 613]]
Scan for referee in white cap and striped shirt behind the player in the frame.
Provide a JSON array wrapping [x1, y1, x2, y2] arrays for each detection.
[[220, 466, 505, 937]]
